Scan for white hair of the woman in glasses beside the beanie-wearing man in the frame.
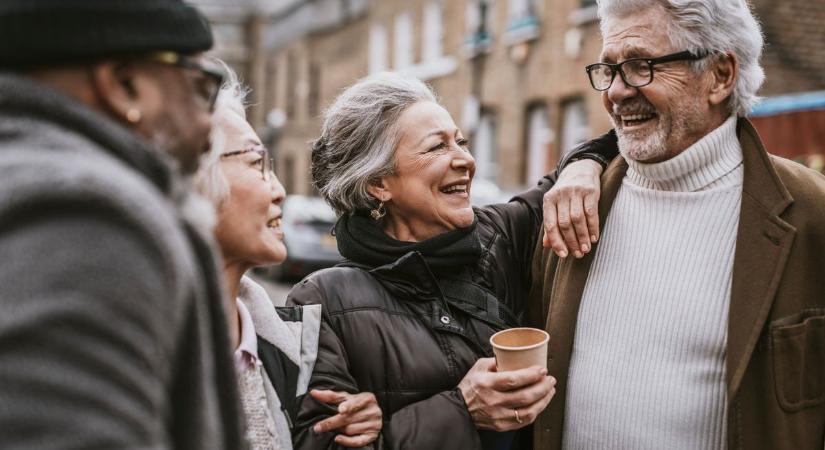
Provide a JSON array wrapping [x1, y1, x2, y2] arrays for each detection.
[[195, 58, 249, 208]]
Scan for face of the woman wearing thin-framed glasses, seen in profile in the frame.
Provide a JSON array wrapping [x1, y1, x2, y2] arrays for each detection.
[[215, 112, 286, 267]]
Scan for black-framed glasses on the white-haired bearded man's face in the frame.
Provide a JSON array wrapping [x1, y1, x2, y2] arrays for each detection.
[[585, 50, 709, 91]]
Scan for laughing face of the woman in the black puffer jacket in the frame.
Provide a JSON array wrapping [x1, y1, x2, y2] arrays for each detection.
[[371, 101, 475, 241]]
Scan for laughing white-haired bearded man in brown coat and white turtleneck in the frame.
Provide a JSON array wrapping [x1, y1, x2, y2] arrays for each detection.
[[534, 0, 825, 450]]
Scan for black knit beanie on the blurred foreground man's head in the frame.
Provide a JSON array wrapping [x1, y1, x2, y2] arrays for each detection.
[[0, 0, 212, 67]]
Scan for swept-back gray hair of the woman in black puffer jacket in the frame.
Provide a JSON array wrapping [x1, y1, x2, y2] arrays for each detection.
[[312, 72, 437, 215]]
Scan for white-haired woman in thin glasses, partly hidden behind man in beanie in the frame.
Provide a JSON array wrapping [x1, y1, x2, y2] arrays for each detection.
[[196, 65, 382, 450]]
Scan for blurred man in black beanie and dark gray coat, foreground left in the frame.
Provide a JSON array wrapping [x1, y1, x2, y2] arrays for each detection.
[[0, 0, 244, 449]]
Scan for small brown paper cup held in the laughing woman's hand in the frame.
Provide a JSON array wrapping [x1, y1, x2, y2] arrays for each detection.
[[490, 328, 550, 372]]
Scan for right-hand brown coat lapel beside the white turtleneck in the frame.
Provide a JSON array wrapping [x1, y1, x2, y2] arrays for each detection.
[[726, 119, 796, 400]]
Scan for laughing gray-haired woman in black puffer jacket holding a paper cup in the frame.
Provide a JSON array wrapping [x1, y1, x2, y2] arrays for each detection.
[[288, 73, 616, 450]]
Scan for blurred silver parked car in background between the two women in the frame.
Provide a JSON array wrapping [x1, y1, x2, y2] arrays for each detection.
[[260, 195, 342, 280]]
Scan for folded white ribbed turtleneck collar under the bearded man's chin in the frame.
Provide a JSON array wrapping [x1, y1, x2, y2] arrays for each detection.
[[626, 115, 742, 192]]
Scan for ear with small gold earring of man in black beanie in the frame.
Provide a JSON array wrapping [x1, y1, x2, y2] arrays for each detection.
[[89, 61, 152, 129]]
